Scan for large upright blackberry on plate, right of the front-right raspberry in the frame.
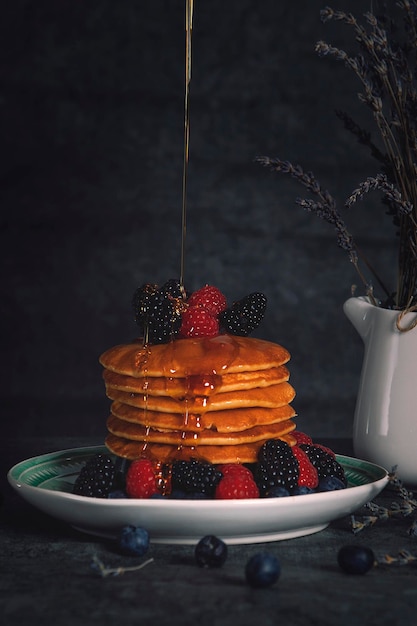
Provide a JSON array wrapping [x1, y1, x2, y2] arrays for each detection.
[[255, 439, 299, 496]]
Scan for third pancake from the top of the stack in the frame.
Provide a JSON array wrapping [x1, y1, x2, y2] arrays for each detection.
[[106, 383, 295, 415]]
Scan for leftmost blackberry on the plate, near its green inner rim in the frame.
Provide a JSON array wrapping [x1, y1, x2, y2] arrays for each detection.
[[72, 454, 115, 498]]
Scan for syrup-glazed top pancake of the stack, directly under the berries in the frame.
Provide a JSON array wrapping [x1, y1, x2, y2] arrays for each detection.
[[99, 335, 290, 378]]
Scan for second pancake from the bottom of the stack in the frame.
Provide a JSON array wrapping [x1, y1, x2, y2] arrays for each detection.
[[107, 415, 294, 447]]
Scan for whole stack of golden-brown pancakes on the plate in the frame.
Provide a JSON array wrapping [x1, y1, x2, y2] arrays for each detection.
[[100, 335, 295, 463]]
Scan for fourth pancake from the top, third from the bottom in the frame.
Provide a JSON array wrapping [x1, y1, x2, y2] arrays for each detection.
[[111, 402, 296, 433]]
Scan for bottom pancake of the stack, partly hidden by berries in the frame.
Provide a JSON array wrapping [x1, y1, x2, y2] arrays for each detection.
[[105, 425, 296, 464]]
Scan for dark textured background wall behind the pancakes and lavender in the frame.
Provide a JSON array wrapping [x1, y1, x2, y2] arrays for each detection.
[[0, 0, 394, 438]]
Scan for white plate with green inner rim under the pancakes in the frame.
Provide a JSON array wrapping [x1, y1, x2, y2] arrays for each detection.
[[8, 446, 388, 544]]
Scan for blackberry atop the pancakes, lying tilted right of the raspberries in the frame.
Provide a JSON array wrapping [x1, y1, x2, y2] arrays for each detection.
[[219, 292, 267, 337]]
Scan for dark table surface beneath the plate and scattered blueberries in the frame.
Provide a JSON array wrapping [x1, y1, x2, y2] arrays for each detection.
[[0, 437, 417, 626]]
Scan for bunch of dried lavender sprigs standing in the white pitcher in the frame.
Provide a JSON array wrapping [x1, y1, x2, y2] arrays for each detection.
[[257, 0, 417, 310]]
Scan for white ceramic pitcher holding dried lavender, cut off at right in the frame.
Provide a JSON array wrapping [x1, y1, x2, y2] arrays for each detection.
[[344, 298, 417, 486]]
